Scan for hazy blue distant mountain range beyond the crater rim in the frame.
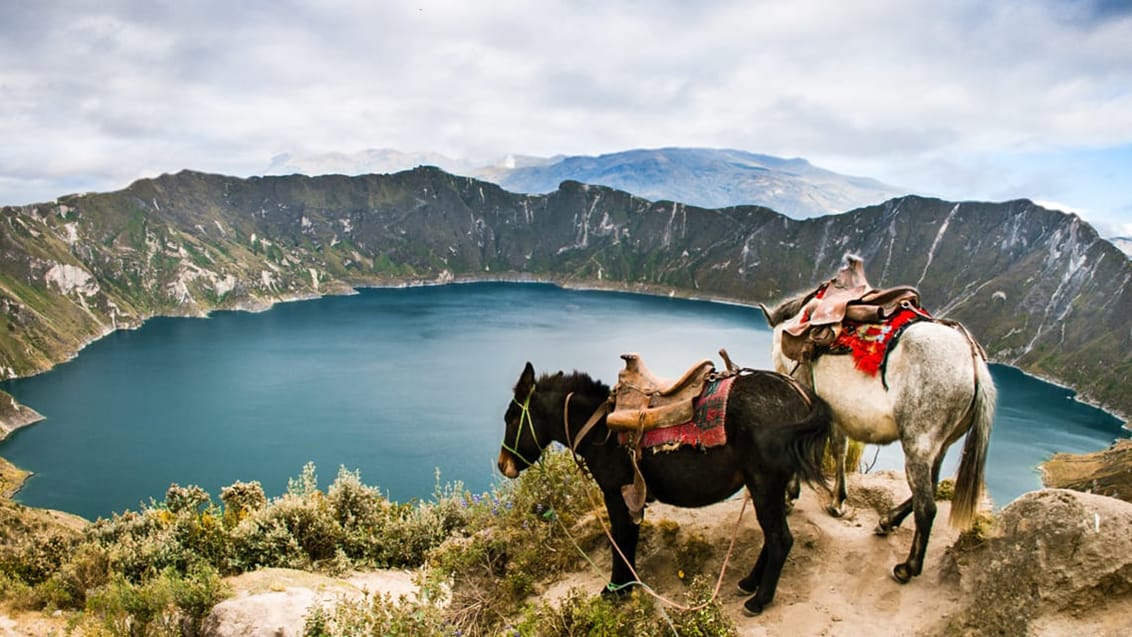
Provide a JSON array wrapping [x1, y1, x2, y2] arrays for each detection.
[[266, 148, 909, 218]]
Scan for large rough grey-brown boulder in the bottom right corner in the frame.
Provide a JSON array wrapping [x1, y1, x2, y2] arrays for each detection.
[[946, 489, 1132, 636]]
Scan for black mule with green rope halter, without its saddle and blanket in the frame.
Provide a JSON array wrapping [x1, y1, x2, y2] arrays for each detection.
[[499, 363, 831, 614]]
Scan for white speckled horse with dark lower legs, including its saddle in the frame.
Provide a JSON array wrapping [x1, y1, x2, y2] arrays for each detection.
[[763, 255, 996, 583]]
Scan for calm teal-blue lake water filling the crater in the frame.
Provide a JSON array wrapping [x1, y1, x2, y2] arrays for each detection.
[[0, 283, 1127, 519]]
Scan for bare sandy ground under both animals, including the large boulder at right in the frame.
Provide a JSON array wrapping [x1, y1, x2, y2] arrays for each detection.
[[547, 472, 1132, 637]]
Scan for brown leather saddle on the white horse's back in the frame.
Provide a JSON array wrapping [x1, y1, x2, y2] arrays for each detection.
[[782, 255, 920, 362]]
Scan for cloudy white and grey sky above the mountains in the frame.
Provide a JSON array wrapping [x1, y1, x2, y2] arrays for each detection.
[[0, 0, 1132, 235]]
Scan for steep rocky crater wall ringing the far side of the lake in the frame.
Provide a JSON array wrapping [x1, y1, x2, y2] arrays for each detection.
[[0, 167, 1132, 414]]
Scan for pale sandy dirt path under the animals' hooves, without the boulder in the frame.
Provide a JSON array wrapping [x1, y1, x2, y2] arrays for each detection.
[[544, 472, 960, 637]]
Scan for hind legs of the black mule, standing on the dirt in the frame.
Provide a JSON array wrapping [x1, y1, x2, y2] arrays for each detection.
[[739, 475, 794, 617]]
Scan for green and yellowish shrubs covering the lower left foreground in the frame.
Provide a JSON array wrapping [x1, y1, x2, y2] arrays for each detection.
[[0, 450, 701, 636]]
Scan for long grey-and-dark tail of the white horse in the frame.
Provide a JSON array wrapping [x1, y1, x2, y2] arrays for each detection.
[[949, 356, 998, 531]]
